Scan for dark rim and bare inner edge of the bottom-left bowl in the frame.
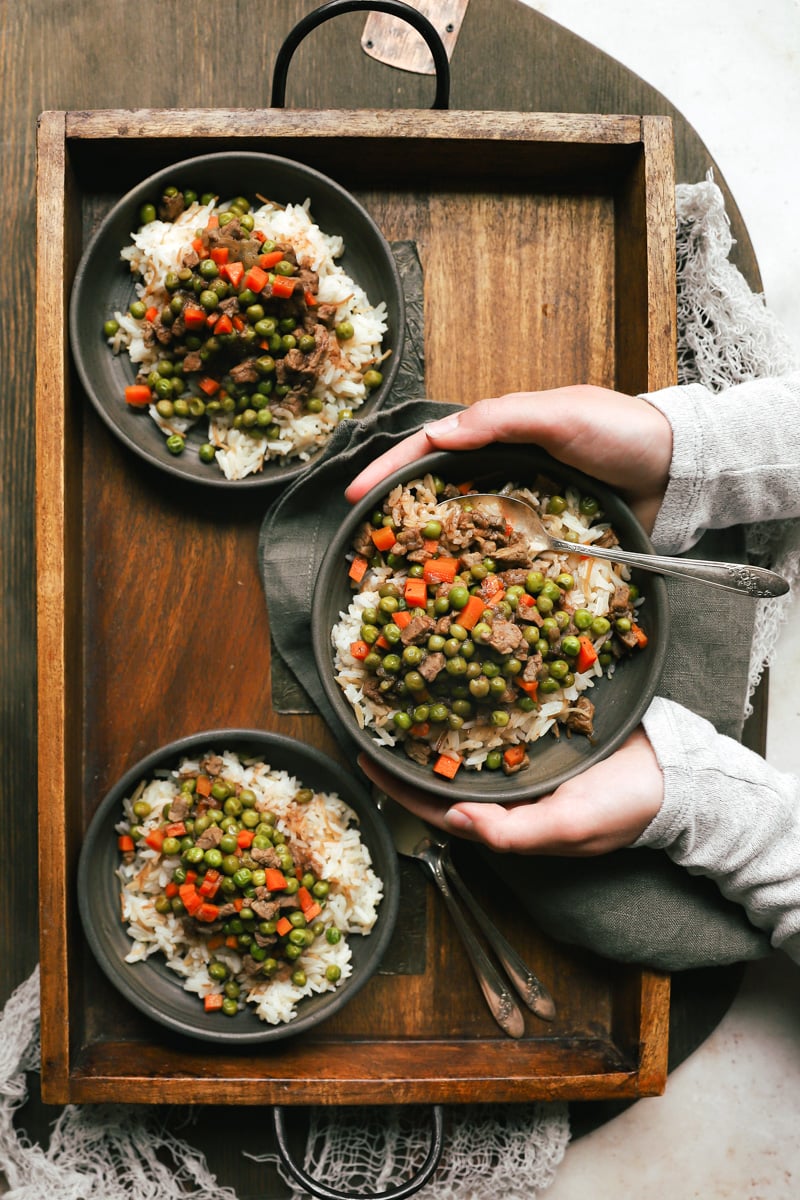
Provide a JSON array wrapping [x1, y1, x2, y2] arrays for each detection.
[[77, 727, 399, 1049]]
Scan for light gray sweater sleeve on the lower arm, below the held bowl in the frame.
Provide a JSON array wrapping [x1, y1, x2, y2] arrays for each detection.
[[633, 698, 800, 962]]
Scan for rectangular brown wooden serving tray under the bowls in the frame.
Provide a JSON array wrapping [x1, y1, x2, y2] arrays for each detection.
[[36, 109, 675, 1104]]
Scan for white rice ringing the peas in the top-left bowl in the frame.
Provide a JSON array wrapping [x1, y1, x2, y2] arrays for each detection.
[[108, 200, 387, 480]]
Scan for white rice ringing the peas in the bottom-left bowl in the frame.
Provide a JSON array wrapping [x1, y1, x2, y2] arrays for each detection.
[[116, 752, 383, 1025]]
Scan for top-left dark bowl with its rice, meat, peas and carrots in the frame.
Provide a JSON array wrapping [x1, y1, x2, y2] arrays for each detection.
[[70, 152, 404, 488]]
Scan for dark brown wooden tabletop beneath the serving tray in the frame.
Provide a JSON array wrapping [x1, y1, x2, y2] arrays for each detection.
[[0, 0, 760, 1198]]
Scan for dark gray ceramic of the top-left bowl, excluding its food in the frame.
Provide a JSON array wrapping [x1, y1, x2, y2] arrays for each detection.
[[70, 151, 405, 490]]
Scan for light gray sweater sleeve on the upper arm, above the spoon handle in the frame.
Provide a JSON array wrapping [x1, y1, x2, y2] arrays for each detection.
[[643, 372, 800, 554]]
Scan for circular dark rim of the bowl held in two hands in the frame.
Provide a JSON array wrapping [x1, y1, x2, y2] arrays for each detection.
[[311, 442, 669, 804]]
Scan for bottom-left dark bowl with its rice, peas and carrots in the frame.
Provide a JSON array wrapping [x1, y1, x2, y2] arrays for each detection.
[[78, 730, 397, 1045]]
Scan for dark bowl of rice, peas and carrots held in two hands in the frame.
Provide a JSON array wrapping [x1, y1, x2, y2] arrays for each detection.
[[313, 445, 668, 803]]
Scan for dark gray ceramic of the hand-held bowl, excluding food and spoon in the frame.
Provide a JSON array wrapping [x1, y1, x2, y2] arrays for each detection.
[[312, 445, 669, 804]]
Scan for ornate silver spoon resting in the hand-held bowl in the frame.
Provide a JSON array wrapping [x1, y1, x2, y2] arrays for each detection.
[[437, 492, 789, 598]]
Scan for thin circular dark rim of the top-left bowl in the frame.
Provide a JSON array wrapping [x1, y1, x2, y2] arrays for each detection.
[[67, 150, 405, 492]]
